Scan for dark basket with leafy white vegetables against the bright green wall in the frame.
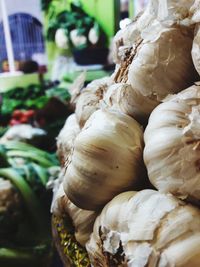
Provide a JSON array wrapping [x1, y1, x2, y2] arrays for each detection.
[[45, 0, 108, 65]]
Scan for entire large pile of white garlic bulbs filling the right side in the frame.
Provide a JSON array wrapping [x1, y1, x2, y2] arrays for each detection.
[[52, 0, 200, 267]]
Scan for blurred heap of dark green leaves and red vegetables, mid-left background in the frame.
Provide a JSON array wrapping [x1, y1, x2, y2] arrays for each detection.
[[0, 81, 72, 150]]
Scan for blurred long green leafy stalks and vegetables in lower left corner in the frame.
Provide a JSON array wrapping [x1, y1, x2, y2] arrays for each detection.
[[0, 140, 60, 267]]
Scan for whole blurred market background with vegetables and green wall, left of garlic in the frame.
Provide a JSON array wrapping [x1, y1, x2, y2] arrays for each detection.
[[0, 0, 147, 267]]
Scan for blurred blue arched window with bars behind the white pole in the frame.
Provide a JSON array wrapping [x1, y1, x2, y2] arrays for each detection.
[[0, 0, 46, 72]]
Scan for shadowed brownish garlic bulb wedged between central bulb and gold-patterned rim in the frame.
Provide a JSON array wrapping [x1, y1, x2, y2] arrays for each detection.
[[52, 184, 98, 246]]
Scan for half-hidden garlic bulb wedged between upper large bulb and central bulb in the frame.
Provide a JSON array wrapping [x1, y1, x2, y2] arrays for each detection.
[[101, 83, 157, 124]]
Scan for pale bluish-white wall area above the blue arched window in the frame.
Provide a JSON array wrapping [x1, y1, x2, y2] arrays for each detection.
[[0, 0, 42, 22]]
